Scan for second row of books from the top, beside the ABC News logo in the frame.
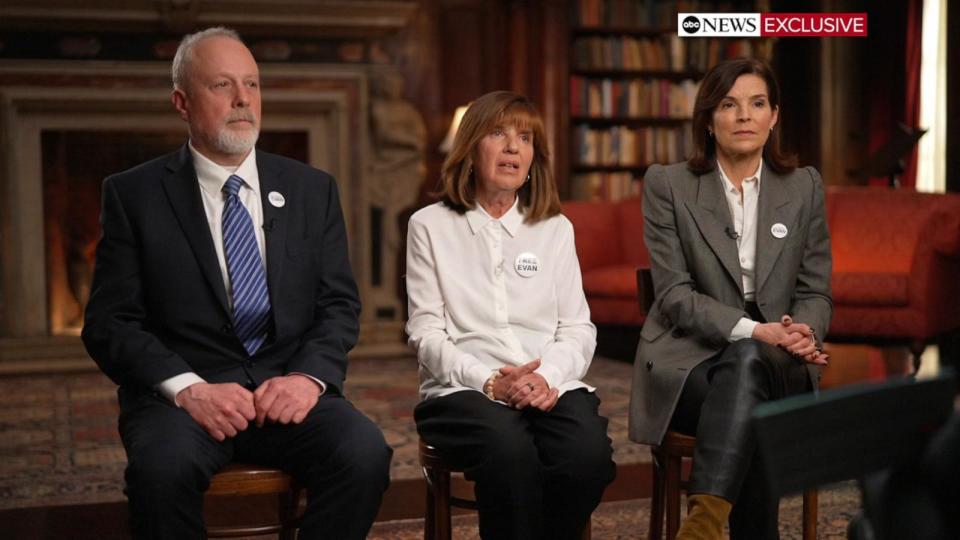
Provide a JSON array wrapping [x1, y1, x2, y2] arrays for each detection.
[[573, 34, 755, 72]]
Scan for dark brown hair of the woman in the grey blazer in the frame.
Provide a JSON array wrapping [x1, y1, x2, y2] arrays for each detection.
[[687, 58, 797, 174]]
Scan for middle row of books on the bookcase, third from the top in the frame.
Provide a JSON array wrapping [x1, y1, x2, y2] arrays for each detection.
[[570, 76, 700, 118]]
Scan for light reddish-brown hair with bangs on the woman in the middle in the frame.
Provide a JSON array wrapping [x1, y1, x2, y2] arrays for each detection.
[[438, 90, 560, 223]]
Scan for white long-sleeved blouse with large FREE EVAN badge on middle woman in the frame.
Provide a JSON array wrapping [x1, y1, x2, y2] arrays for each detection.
[[407, 201, 597, 399]]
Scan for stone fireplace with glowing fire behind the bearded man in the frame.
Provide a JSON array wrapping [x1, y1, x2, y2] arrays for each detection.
[[0, 62, 402, 352]]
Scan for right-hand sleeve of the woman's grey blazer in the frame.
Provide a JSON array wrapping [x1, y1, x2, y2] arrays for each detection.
[[790, 167, 833, 343]]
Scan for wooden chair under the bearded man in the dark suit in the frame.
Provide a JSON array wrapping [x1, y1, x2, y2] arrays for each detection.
[[206, 463, 303, 540]]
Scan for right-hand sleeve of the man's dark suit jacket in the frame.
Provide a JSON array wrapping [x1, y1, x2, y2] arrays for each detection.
[[286, 177, 360, 393]]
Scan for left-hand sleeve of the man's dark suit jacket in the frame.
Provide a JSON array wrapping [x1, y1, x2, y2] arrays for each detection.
[[82, 178, 192, 388]]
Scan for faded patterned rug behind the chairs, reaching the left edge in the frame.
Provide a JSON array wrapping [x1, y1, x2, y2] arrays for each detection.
[[0, 357, 649, 509]]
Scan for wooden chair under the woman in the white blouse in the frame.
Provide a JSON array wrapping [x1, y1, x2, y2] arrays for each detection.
[[420, 440, 590, 540]]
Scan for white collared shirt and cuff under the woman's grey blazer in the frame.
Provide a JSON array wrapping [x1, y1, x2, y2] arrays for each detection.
[[717, 158, 763, 341]]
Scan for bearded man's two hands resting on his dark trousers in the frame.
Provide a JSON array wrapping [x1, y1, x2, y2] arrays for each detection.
[[177, 374, 320, 441]]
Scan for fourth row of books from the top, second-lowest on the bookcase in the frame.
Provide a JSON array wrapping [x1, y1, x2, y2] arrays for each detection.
[[573, 123, 691, 167]]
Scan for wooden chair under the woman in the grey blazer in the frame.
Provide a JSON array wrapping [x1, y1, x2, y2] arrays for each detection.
[[637, 268, 817, 540]]
